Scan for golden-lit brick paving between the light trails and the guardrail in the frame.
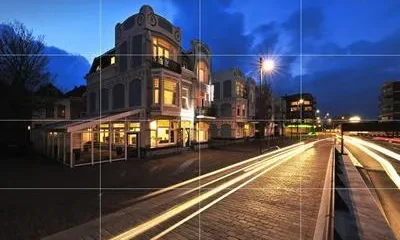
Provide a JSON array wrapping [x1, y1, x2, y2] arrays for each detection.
[[164, 142, 332, 239]]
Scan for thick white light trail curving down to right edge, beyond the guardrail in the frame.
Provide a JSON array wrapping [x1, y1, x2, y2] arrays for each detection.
[[345, 137, 400, 189]]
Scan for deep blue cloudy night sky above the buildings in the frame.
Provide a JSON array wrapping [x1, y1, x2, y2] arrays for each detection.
[[0, 0, 400, 119]]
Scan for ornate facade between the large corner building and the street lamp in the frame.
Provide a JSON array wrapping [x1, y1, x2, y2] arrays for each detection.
[[210, 68, 255, 139]]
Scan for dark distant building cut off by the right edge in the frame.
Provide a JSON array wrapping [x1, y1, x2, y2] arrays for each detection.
[[379, 81, 400, 120]]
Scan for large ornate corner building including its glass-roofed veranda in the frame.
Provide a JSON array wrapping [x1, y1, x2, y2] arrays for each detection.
[[31, 5, 212, 166]]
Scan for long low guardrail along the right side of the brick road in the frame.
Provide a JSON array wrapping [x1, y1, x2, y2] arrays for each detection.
[[313, 147, 339, 240]]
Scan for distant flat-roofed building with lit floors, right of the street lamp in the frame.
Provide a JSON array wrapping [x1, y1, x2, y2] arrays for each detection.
[[283, 93, 317, 135]]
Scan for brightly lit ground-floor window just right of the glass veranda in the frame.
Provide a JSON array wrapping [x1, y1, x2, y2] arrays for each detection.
[[150, 120, 177, 147]]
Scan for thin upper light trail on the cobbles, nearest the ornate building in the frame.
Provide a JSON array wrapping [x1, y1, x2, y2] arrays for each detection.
[[135, 142, 304, 201]]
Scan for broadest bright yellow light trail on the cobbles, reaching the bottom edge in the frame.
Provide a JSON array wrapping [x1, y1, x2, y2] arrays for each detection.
[[111, 142, 316, 240]]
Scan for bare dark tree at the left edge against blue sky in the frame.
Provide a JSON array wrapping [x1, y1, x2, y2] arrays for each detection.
[[0, 21, 51, 119]]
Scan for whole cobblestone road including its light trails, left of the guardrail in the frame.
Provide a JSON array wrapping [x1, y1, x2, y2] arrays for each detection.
[[43, 140, 333, 239]]
